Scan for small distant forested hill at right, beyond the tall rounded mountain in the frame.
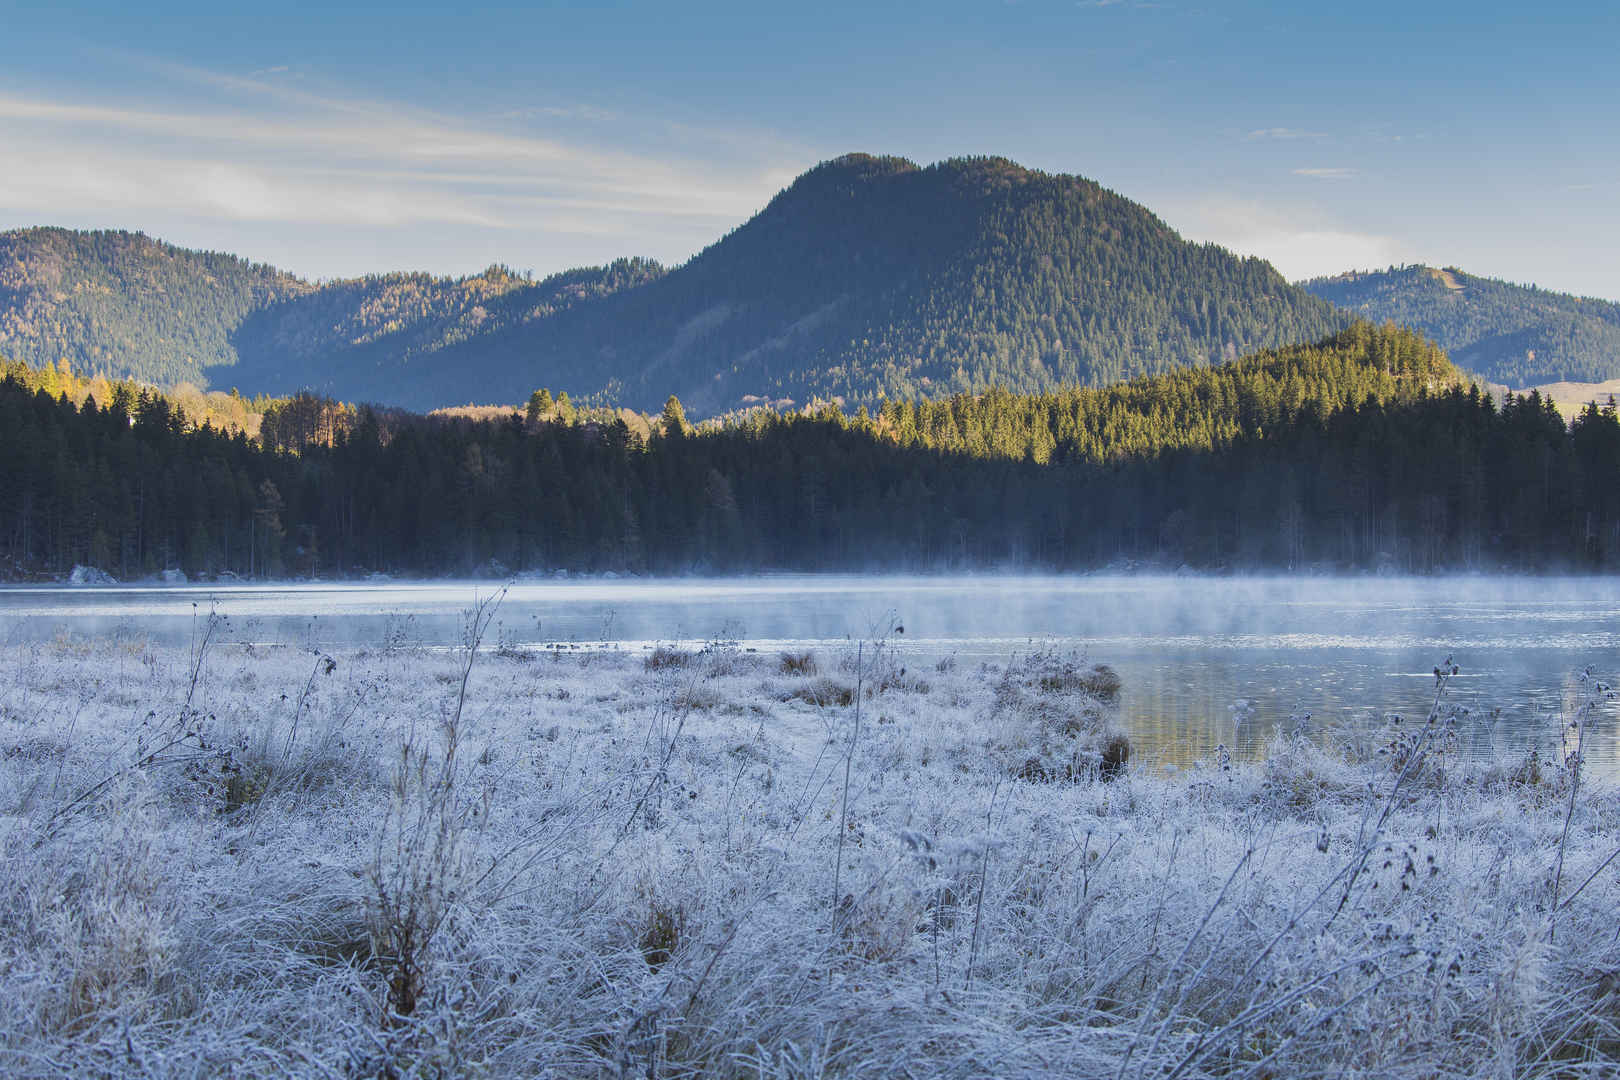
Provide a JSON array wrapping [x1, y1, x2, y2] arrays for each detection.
[[1301, 266, 1620, 387]]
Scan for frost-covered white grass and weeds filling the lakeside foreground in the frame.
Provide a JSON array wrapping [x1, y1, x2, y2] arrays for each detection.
[[0, 615, 1620, 1078]]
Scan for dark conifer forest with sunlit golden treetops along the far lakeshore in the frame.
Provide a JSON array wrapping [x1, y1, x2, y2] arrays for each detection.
[[0, 324, 1620, 578]]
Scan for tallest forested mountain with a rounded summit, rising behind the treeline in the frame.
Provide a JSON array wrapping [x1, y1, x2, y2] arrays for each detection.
[[364, 155, 1345, 413]]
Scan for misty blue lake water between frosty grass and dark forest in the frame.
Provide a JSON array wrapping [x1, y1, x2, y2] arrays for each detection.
[[0, 575, 1620, 776]]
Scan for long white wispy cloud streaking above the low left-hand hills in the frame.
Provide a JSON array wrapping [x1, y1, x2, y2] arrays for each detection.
[[0, 58, 815, 276]]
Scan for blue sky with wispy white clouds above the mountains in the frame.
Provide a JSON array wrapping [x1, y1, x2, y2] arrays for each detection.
[[0, 0, 1620, 298]]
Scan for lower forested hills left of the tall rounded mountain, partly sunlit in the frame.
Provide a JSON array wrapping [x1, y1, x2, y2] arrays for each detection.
[[0, 228, 663, 396]]
